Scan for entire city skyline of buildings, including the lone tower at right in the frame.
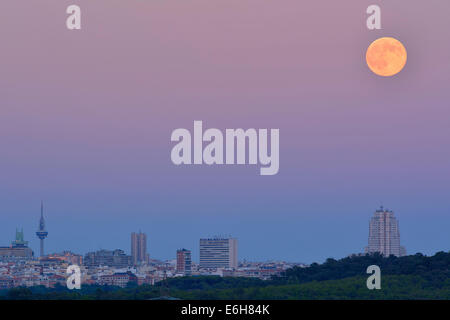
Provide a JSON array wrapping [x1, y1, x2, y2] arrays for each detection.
[[0, 204, 406, 290]]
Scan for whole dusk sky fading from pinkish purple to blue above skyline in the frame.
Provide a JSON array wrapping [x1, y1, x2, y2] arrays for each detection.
[[0, 0, 450, 262]]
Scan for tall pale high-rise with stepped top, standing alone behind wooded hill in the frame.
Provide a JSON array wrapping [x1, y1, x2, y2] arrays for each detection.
[[365, 207, 406, 257]]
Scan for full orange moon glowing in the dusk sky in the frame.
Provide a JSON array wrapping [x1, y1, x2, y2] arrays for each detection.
[[366, 37, 407, 77]]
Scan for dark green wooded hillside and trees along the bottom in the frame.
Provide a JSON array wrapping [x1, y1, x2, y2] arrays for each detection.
[[0, 252, 450, 299]]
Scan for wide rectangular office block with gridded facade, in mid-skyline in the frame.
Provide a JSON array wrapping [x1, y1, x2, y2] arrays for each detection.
[[200, 238, 237, 269]]
